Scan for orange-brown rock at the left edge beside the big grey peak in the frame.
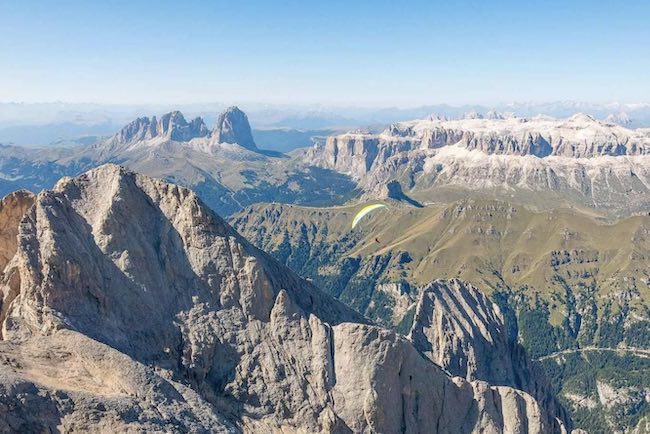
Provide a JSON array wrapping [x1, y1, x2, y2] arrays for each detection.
[[0, 190, 35, 272]]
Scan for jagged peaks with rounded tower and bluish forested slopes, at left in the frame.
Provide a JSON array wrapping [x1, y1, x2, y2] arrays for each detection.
[[0, 107, 357, 215]]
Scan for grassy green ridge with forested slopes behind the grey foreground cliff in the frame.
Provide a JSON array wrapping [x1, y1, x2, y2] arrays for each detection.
[[231, 199, 650, 432]]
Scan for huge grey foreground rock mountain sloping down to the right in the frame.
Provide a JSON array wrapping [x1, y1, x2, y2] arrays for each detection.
[[0, 165, 561, 432]]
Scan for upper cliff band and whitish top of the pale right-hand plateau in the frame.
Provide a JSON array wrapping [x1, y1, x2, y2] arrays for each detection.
[[311, 114, 650, 178]]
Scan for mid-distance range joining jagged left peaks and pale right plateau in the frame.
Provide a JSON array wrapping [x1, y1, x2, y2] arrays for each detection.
[[0, 107, 650, 218]]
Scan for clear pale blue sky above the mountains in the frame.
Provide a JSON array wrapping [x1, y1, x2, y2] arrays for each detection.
[[0, 0, 650, 106]]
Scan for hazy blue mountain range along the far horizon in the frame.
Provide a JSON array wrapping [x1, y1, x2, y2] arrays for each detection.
[[0, 101, 650, 151]]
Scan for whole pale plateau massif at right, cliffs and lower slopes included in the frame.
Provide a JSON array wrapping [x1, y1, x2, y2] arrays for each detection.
[[304, 114, 650, 215]]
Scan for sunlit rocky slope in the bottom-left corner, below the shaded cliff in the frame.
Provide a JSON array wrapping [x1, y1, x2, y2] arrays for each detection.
[[0, 330, 237, 434]]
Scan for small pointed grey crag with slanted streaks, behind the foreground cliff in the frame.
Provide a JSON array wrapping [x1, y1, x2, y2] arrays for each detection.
[[408, 279, 569, 430]]
